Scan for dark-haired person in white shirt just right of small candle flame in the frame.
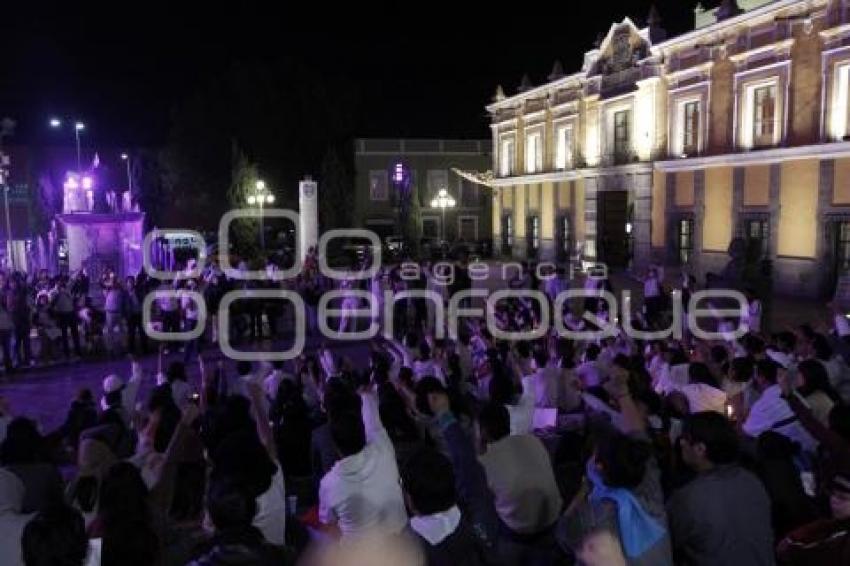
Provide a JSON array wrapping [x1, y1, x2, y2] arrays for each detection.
[[742, 360, 817, 451]]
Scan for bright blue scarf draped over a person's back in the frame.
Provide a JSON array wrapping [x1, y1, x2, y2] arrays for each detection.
[[587, 460, 667, 559]]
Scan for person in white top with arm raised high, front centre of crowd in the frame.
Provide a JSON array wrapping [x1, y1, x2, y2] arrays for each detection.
[[319, 390, 407, 537]]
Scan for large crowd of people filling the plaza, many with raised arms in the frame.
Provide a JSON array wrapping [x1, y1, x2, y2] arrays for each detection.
[[0, 257, 850, 566]]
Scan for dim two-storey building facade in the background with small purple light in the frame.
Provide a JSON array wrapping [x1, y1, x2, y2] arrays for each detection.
[[354, 139, 493, 247]]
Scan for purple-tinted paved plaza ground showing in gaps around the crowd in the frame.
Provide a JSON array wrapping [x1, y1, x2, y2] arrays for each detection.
[[0, 264, 829, 430]]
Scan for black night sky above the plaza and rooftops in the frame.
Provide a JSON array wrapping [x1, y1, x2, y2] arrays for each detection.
[[0, 0, 717, 146]]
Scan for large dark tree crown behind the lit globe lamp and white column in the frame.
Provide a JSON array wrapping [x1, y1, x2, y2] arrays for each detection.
[[163, 62, 357, 237]]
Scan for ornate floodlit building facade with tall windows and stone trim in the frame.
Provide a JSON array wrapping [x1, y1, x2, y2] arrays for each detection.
[[487, 0, 850, 296]]
